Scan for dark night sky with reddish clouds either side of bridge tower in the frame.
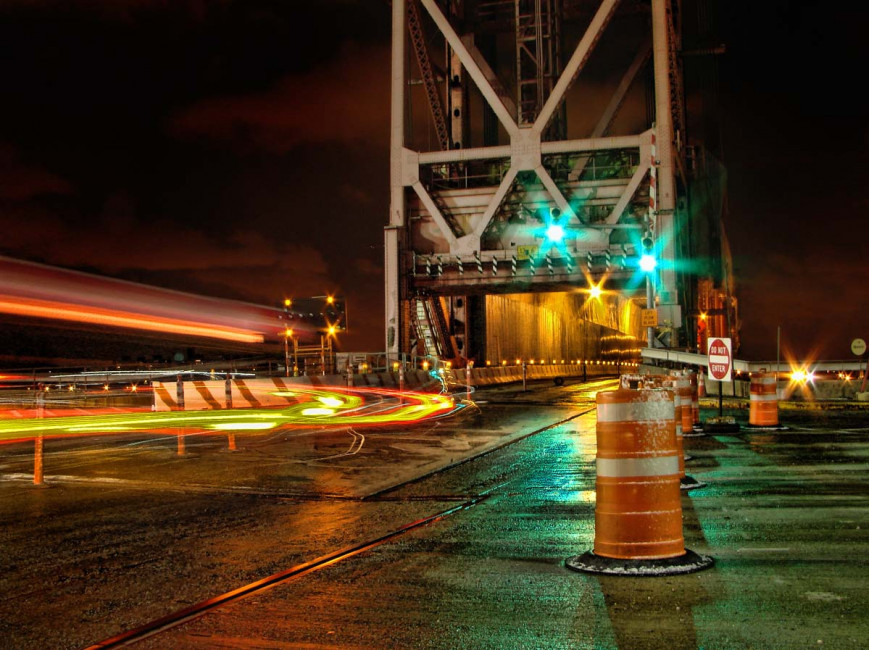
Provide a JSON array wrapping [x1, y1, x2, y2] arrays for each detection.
[[0, 0, 869, 359]]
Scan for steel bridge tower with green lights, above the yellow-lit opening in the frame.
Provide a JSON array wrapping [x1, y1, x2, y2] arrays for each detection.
[[385, 0, 722, 358]]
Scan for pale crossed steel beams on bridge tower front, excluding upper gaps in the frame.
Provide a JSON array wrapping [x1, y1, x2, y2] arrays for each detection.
[[385, 0, 681, 355]]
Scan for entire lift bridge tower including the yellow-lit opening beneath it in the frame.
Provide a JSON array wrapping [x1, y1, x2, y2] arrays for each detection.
[[385, 0, 738, 363]]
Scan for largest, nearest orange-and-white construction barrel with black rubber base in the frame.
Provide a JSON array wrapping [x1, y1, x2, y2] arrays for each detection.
[[566, 389, 712, 575]]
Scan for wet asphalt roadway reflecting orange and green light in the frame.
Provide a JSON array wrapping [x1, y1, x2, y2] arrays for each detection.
[[0, 380, 869, 649]]
